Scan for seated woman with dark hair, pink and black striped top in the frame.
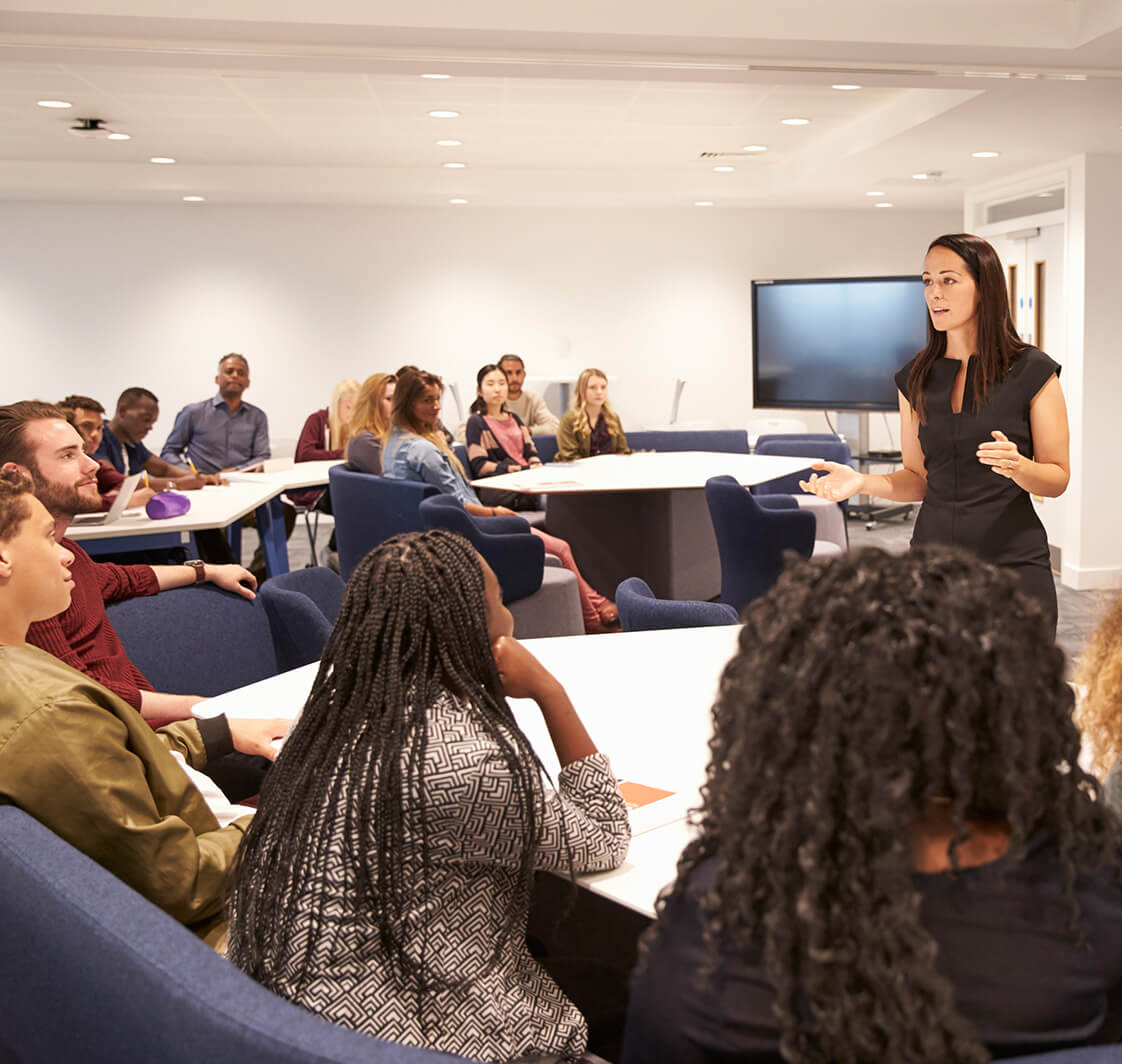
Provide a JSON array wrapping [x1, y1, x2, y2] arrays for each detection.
[[467, 365, 542, 510]]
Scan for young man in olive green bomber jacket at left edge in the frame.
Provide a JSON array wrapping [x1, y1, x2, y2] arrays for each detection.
[[0, 469, 287, 945]]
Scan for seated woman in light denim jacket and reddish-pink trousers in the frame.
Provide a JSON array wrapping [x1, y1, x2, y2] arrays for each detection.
[[381, 373, 619, 634]]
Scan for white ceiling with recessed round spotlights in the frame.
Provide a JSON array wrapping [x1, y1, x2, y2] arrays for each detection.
[[0, 0, 1122, 209]]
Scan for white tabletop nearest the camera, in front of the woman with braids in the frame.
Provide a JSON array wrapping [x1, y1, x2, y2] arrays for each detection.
[[196, 625, 741, 916]]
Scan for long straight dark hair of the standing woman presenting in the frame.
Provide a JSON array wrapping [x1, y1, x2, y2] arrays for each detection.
[[908, 232, 1026, 422]]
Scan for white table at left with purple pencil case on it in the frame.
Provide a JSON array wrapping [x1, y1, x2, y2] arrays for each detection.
[[66, 461, 340, 576]]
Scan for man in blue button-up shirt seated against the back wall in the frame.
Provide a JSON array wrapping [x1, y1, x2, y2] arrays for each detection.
[[162, 354, 270, 474]]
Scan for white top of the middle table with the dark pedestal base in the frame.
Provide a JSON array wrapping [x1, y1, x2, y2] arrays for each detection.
[[471, 451, 819, 495]]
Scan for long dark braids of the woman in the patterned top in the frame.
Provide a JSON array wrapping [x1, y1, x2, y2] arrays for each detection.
[[228, 530, 544, 1005]]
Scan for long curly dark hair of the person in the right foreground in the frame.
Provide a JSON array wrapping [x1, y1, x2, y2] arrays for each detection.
[[654, 548, 1122, 1064]]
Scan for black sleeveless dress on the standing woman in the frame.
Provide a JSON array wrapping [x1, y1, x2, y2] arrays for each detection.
[[895, 347, 1060, 631]]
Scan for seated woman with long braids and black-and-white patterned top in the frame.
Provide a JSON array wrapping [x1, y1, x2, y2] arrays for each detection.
[[228, 531, 631, 1061]]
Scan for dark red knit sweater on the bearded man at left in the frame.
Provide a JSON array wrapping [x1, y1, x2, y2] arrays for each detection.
[[27, 539, 159, 710]]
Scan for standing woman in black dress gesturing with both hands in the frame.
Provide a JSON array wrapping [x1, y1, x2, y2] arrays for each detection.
[[800, 233, 1070, 632]]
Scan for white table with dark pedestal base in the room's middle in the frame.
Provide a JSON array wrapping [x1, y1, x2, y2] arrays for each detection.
[[472, 451, 818, 599]]
